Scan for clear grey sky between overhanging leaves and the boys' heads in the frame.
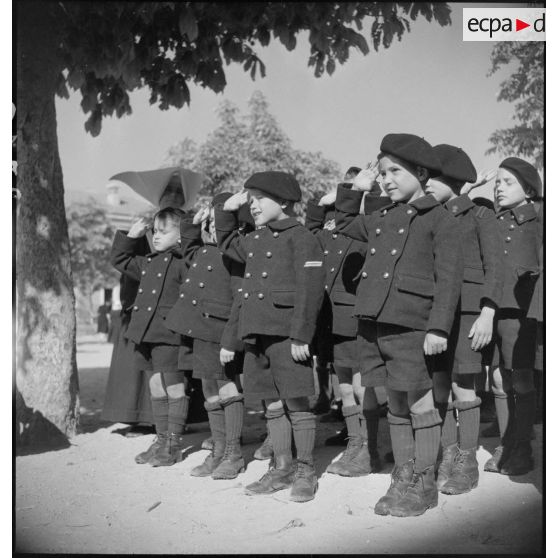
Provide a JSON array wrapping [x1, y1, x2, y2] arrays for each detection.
[[52, 4, 528, 206]]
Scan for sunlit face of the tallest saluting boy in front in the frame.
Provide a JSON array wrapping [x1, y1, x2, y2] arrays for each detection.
[[378, 155, 426, 202]]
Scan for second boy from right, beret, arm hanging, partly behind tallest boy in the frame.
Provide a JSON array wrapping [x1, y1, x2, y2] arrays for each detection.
[[426, 144, 503, 494]]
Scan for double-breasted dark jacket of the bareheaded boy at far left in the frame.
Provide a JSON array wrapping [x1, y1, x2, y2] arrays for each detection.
[[111, 231, 192, 345]]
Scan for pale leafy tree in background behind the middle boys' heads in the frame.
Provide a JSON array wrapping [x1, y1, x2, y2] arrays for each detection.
[[165, 91, 341, 213]]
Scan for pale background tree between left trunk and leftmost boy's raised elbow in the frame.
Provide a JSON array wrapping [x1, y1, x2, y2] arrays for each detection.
[[66, 199, 120, 324]]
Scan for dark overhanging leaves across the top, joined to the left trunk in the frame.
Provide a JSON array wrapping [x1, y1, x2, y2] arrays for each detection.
[[57, 2, 451, 136]]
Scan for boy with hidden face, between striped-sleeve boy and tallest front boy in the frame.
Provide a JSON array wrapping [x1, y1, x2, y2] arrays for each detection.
[[306, 171, 390, 477]]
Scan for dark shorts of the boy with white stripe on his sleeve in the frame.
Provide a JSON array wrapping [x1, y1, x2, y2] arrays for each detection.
[[244, 335, 315, 399]]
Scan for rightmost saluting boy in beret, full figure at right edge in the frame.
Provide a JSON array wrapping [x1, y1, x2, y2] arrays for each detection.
[[484, 157, 542, 475]]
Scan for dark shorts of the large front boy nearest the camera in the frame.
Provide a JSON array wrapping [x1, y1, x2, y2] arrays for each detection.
[[357, 320, 432, 391]]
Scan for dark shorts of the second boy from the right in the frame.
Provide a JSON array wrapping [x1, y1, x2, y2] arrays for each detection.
[[427, 314, 490, 379]]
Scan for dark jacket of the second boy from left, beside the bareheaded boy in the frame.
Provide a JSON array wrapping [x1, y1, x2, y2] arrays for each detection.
[[166, 221, 244, 351]]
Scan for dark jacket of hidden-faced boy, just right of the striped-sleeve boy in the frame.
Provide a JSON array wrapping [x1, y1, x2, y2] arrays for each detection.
[[305, 196, 390, 337]]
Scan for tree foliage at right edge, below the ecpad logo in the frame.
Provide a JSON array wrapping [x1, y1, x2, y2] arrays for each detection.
[[486, 41, 545, 170]]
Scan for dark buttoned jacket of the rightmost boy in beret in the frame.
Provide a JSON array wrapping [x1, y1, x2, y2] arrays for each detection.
[[496, 203, 541, 311]]
